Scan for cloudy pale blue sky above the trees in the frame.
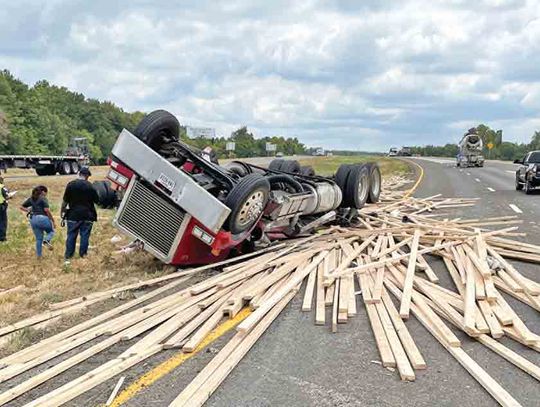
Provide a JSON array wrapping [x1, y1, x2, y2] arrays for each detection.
[[0, 0, 540, 151]]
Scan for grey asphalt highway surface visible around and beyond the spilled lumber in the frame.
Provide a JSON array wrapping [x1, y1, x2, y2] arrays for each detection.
[[4, 159, 540, 407]]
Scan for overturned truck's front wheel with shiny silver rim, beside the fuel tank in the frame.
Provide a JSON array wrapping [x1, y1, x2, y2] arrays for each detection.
[[223, 174, 270, 234]]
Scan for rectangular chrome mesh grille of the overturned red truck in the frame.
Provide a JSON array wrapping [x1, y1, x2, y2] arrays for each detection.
[[117, 181, 185, 258]]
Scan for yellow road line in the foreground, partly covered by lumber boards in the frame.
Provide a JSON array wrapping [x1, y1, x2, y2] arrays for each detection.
[[111, 308, 251, 407]]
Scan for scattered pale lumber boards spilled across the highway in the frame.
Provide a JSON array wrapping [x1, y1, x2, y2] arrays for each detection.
[[0, 193, 540, 406]]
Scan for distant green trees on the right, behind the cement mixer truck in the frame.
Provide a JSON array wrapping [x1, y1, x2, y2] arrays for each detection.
[[411, 124, 540, 161]]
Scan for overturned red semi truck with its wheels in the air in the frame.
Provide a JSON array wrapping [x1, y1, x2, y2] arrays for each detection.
[[103, 110, 381, 265]]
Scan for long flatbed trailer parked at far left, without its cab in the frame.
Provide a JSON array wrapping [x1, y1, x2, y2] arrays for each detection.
[[0, 155, 88, 175]]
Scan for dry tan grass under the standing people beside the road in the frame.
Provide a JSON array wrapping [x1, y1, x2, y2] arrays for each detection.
[[0, 167, 172, 326]]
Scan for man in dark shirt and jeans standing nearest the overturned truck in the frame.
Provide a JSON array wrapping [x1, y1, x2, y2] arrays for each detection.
[[62, 167, 99, 264]]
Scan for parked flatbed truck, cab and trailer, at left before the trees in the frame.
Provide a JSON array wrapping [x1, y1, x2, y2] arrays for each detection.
[[0, 137, 90, 175]]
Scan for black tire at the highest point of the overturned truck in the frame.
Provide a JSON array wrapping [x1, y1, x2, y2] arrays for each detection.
[[133, 110, 180, 151]]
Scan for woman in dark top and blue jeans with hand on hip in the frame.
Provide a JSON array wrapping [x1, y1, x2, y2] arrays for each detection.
[[20, 186, 56, 259]]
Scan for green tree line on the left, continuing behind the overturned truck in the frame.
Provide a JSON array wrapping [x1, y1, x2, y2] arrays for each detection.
[[0, 70, 305, 164]]
